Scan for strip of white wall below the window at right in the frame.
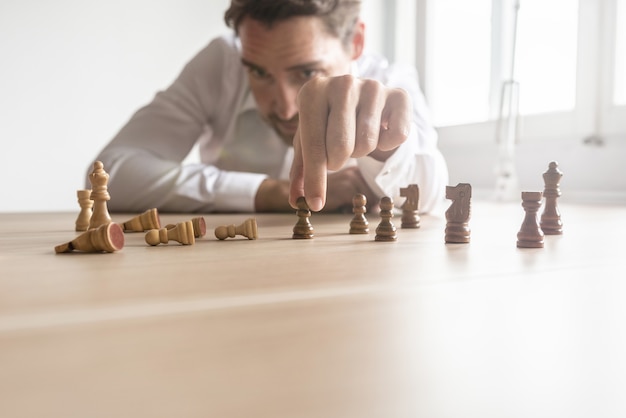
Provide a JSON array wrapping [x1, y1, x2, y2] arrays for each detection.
[[439, 136, 626, 205]]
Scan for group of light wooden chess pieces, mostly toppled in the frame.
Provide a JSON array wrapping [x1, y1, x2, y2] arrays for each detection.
[[54, 161, 258, 253]]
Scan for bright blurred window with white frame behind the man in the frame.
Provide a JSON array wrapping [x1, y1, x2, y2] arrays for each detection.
[[402, 0, 626, 141]]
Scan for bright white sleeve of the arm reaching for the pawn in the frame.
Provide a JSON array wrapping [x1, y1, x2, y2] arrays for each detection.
[[357, 57, 448, 213]]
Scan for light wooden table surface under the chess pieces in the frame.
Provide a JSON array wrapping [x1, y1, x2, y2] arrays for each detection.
[[0, 201, 626, 418]]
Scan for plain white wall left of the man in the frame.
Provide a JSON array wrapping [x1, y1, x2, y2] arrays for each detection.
[[0, 0, 229, 212]]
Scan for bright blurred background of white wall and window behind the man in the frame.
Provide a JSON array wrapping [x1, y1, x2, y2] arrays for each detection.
[[0, 0, 626, 212]]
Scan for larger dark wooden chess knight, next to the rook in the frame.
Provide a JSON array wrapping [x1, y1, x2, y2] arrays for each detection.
[[445, 183, 472, 244]]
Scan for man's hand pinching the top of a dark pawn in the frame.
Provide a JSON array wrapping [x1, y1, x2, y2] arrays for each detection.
[[289, 75, 411, 211]]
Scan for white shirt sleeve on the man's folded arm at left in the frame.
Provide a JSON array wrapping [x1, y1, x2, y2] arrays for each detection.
[[87, 38, 266, 212]]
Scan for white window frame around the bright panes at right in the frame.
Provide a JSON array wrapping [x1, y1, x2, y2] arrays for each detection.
[[404, 0, 626, 143]]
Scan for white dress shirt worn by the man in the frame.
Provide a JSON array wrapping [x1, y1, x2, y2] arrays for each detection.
[[97, 35, 448, 213]]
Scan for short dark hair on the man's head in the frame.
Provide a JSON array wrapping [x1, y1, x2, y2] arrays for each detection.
[[224, 0, 361, 42]]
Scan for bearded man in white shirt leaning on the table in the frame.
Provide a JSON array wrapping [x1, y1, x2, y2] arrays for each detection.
[[91, 0, 447, 212]]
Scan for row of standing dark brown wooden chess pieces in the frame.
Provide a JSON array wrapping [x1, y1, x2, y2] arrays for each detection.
[[292, 161, 563, 248]]
